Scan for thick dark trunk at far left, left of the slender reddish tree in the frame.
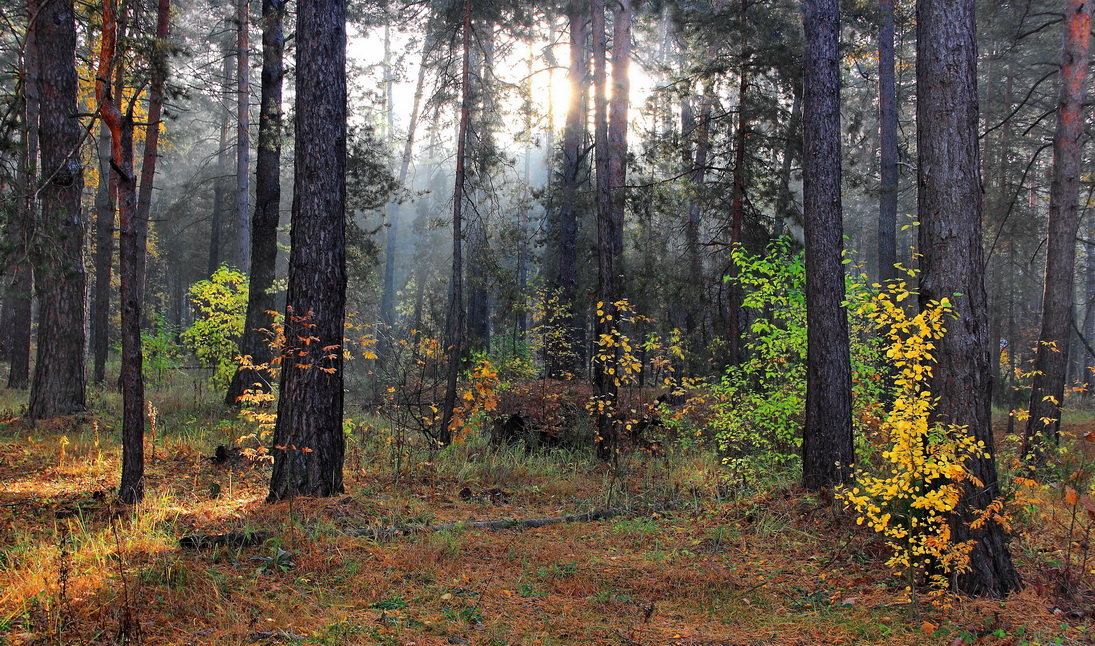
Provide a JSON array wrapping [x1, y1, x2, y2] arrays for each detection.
[[27, 0, 87, 419]]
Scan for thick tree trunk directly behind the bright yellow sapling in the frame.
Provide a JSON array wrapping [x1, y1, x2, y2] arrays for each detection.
[[917, 0, 1019, 597]]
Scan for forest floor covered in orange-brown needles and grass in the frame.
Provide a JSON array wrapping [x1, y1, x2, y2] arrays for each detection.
[[0, 383, 1095, 646]]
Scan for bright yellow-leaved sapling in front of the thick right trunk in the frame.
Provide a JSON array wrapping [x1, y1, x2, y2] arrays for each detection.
[[837, 282, 1002, 598]]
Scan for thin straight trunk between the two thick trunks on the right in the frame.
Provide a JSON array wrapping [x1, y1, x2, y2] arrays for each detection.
[[878, 0, 898, 284]]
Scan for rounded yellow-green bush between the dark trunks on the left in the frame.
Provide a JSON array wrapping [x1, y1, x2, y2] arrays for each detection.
[[183, 265, 249, 388]]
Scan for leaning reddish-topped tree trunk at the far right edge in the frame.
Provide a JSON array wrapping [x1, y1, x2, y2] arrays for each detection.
[[1023, 0, 1093, 464]]
